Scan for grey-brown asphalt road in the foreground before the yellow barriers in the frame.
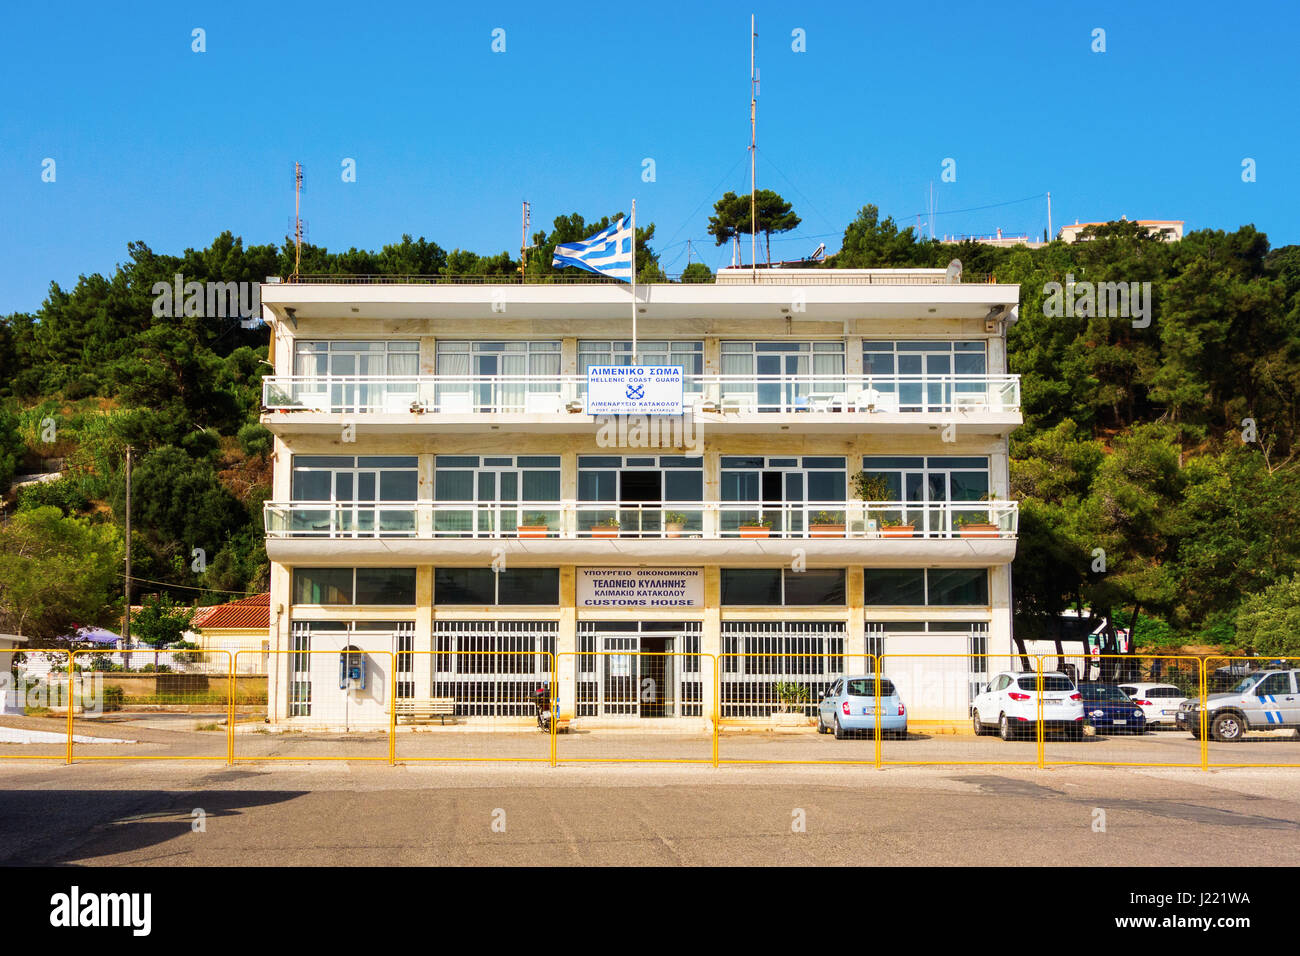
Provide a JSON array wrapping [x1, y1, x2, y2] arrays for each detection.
[[0, 759, 1300, 866]]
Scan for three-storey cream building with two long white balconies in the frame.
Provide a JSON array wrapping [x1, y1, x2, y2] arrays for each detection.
[[261, 269, 1021, 727]]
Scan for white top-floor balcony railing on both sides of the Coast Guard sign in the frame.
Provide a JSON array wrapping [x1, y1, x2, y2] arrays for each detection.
[[261, 375, 1021, 415]]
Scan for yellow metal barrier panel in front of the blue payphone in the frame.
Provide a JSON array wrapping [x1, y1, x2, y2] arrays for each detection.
[[230, 647, 397, 765]]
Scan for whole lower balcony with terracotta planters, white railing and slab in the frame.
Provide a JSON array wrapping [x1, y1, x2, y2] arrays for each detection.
[[265, 501, 1019, 566]]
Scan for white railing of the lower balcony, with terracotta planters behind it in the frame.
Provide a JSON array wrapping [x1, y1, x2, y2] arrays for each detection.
[[265, 501, 1019, 540]]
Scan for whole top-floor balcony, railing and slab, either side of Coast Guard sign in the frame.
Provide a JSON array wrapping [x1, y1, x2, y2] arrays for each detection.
[[263, 375, 1021, 432]]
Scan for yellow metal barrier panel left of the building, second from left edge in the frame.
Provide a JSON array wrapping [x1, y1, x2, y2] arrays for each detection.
[[68, 648, 235, 763]]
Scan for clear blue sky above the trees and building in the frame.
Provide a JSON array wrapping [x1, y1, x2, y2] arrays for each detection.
[[0, 0, 1300, 313]]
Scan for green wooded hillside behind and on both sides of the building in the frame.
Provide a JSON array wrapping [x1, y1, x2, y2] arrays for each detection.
[[0, 208, 1300, 653]]
